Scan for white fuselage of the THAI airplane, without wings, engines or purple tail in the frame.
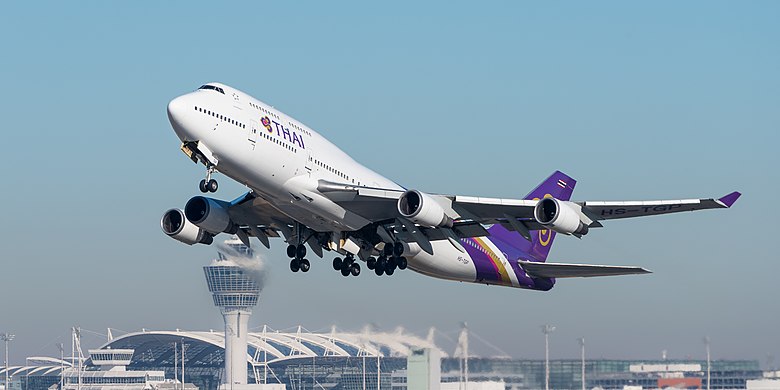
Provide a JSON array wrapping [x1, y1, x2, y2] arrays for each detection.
[[168, 83, 519, 286]]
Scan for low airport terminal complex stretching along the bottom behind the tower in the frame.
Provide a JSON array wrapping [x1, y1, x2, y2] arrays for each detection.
[[0, 328, 767, 390]]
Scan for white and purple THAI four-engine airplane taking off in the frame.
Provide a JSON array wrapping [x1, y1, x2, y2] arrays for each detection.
[[160, 82, 741, 291]]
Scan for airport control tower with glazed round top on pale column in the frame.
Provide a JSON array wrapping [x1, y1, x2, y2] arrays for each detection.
[[203, 239, 261, 389]]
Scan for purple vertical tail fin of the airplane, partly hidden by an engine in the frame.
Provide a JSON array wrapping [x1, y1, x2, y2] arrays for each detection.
[[488, 171, 577, 262]]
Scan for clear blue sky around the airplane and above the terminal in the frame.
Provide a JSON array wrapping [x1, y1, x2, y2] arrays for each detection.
[[0, 1, 780, 362]]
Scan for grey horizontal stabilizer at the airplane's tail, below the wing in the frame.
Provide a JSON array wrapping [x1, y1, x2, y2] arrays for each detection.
[[517, 260, 650, 278]]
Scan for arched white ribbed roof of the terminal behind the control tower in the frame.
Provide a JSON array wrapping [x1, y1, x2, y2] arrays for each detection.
[[101, 327, 448, 365]]
